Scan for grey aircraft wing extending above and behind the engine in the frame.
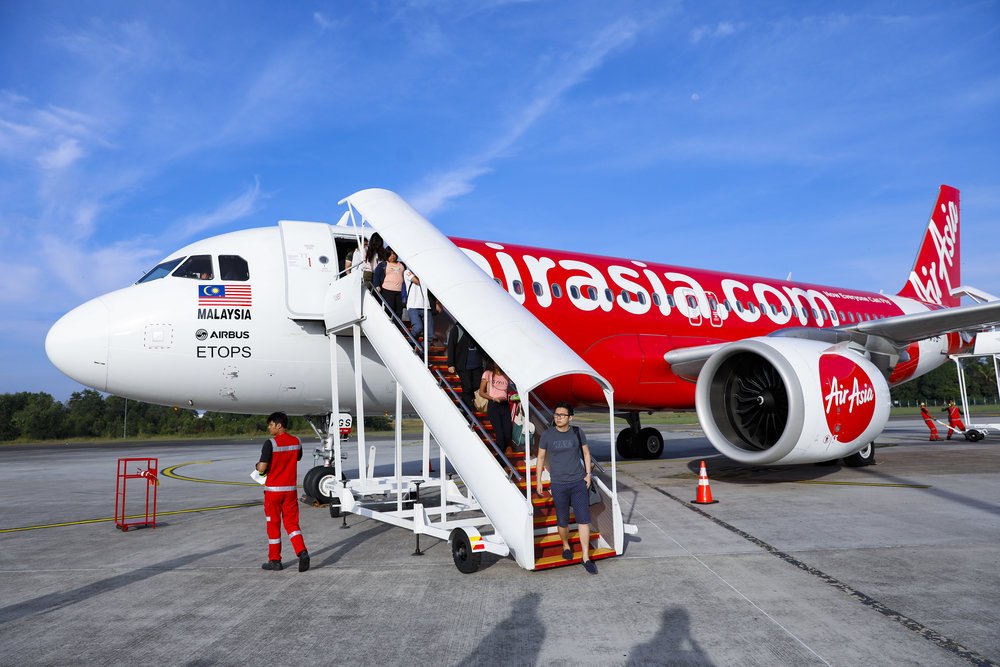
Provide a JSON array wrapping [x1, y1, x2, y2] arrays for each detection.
[[663, 301, 1000, 382]]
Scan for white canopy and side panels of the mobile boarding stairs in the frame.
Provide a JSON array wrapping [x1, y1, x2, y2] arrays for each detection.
[[323, 189, 625, 570]]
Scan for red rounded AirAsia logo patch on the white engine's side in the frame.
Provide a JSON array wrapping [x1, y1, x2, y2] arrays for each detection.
[[819, 354, 875, 442]]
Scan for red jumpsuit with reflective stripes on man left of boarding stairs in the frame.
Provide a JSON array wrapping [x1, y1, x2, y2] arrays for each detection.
[[260, 433, 306, 560]]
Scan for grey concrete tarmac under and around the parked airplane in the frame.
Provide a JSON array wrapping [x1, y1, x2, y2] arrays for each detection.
[[0, 420, 1000, 665]]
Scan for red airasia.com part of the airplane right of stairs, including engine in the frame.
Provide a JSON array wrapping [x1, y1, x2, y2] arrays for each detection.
[[453, 186, 997, 465]]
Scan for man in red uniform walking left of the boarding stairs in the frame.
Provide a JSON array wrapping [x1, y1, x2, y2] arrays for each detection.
[[257, 412, 309, 572]]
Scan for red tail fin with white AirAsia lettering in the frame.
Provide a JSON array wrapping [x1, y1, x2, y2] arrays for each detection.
[[899, 185, 962, 308]]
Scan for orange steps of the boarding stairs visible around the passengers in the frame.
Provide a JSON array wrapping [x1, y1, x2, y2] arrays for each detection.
[[420, 339, 615, 570]]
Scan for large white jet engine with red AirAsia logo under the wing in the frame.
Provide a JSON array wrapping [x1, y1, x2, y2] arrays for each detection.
[[695, 338, 891, 465]]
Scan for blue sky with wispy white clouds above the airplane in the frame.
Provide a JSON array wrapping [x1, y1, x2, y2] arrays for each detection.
[[0, 0, 1000, 400]]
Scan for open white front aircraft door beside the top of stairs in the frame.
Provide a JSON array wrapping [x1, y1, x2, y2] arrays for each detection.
[[278, 220, 339, 320]]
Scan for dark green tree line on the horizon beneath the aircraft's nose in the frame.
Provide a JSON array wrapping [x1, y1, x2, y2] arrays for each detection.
[[0, 389, 392, 441]]
